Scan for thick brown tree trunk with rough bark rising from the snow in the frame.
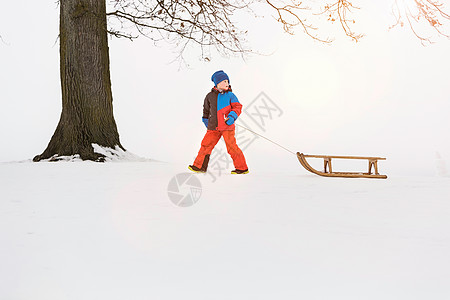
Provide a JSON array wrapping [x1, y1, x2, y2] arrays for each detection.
[[33, 0, 123, 161]]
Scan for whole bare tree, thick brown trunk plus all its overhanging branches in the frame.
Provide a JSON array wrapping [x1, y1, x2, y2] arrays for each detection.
[[33, 0, 450, 161]]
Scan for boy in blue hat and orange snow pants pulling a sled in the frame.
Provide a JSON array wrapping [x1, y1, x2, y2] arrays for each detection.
[[189, 70, 248, 174]]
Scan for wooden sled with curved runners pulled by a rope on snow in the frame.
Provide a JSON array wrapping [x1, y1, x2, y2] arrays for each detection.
[[297, 152, 387, 179]]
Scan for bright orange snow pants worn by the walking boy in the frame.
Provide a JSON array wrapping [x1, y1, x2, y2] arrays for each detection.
[[194, 130, 248, 171]]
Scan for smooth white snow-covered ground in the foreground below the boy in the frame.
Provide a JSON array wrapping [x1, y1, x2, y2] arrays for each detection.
[[0, 159, 450, 300]]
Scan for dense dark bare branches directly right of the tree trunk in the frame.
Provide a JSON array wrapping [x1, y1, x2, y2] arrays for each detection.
[[107, 0, 251, 57]]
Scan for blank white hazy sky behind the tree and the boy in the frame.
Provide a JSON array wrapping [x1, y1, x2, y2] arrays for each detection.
[[0, 0, 450, 175]]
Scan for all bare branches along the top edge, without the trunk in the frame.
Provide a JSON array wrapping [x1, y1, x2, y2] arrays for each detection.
[[102, 0, 450, 60]]
